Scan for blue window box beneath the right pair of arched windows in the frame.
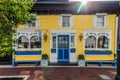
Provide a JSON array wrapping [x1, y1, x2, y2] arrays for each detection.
[[85, 51, 111, 55]]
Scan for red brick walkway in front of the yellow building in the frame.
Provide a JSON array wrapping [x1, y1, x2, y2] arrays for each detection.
[[0, 67, 116, 80]]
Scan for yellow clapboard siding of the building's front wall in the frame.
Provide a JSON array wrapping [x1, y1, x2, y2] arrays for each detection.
[[16, 14, 116, 60]]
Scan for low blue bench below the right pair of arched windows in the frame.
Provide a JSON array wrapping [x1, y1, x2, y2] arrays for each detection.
[[85, 60, 116, 67]]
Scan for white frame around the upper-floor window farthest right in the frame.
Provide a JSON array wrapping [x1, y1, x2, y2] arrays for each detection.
[[94, 13, 107, 28]]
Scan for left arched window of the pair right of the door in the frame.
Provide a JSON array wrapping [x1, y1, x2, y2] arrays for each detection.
[[85, 36, 96, 48]]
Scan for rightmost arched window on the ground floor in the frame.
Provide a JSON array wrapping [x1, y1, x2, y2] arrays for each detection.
[[98, 36, 109, 48]]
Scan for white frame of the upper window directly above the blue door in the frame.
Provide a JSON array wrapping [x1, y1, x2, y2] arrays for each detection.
[[59, 14, 73, 28]]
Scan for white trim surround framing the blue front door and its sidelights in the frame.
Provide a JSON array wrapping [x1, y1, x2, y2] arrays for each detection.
[[50, 30, 77, 63]]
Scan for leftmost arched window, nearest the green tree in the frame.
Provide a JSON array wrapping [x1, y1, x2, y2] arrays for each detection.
[[17, 36, 29, 48]]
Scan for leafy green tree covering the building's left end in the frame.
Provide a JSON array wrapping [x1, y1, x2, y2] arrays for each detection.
[[0, 0, 35, 57]]
